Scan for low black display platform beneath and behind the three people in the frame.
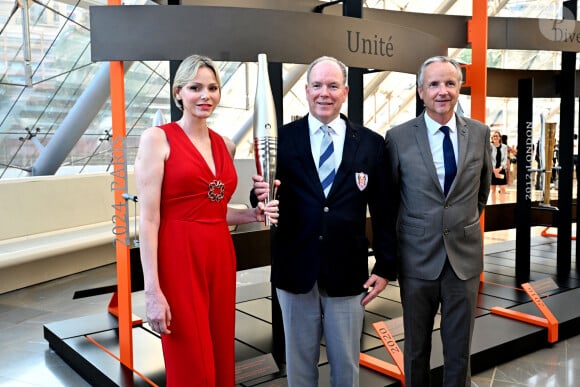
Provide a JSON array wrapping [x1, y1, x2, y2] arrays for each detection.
[[44, 237, 580, 387]]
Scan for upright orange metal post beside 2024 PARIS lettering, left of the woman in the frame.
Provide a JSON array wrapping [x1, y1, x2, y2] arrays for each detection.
[[107, 0, 133, 369]]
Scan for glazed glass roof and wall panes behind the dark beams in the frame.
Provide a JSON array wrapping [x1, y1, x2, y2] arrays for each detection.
[[0, 0, 578, 179]]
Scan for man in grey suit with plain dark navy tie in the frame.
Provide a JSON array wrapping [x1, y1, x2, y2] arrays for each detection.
[[385, 57, 492, 387]]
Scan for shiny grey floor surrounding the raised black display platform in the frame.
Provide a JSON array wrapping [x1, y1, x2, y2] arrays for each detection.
[[0, 186, 580, 387]]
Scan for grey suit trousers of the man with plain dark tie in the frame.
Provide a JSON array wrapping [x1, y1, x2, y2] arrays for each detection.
[[399, 262, 479, 387]]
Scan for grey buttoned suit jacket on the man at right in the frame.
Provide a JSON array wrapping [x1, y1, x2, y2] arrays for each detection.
[[385, 113, 492, 280]]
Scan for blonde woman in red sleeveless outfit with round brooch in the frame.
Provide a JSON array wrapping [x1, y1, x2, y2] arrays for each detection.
[[135, 55, 278, 387]]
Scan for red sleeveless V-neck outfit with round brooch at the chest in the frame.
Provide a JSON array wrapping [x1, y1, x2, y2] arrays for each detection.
[[158, 122, 237, 387]]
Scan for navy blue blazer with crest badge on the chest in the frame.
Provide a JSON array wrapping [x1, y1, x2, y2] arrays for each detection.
[[271, 115, 396, 297]]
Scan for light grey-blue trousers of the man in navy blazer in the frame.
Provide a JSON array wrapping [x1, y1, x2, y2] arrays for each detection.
[[276, 284, 364, 387]]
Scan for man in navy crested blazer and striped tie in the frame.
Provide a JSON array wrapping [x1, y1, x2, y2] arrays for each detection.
[[254, 57, 396, 387]]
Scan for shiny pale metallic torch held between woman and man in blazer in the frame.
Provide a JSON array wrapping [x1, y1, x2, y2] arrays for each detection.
[[254, 54, 278, 226]]
